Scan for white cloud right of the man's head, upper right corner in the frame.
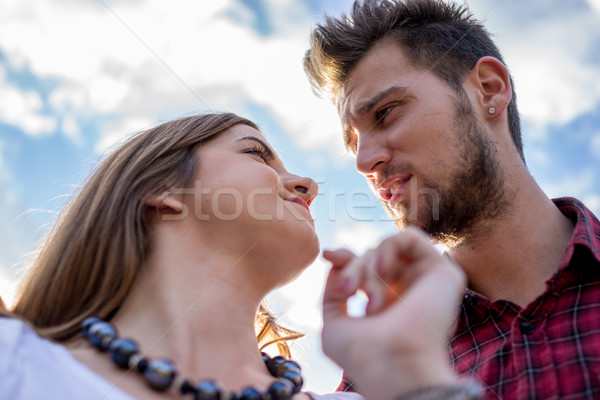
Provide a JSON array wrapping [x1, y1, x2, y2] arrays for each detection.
[[469, 0, 600, 125]]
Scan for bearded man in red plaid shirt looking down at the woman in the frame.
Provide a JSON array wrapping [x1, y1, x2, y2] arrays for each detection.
[[304, 0, 600, 399]]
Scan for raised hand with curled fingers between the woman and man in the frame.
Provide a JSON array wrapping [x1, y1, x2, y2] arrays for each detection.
[[322, 228, 466, 400]]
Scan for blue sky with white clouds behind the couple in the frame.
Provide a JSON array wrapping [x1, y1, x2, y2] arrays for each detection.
[[0, 0, 600, 392]]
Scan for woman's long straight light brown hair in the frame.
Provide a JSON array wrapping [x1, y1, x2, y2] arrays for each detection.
[[2, 113, 298, 355]]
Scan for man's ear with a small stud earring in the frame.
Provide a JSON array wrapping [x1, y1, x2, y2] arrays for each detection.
[[470, 56, 512, 119]]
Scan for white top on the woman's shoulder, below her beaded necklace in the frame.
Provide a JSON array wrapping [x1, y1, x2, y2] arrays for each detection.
[[0, 318, 364, 400]]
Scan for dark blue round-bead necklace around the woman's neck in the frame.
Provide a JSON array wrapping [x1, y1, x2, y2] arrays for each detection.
[[81, 317, 304, 400]]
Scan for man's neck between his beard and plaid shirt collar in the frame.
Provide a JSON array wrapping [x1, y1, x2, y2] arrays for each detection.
[[449, 177, 573, 307]]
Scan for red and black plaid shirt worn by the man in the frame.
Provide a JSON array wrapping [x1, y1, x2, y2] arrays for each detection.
[[450, 198, 600, 400]]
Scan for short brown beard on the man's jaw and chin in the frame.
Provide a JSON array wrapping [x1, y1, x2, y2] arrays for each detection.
[[384, 93, 511, 247]]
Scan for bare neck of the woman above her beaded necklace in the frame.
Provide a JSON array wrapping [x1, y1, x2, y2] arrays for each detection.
[[112, 245, 272, 390]]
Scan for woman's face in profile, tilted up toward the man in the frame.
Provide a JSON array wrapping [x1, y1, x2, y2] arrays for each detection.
[[186, 124, 319, 282]]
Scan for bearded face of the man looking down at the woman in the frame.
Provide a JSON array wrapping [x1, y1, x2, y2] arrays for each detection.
[[338, 41, 508, 245]]
